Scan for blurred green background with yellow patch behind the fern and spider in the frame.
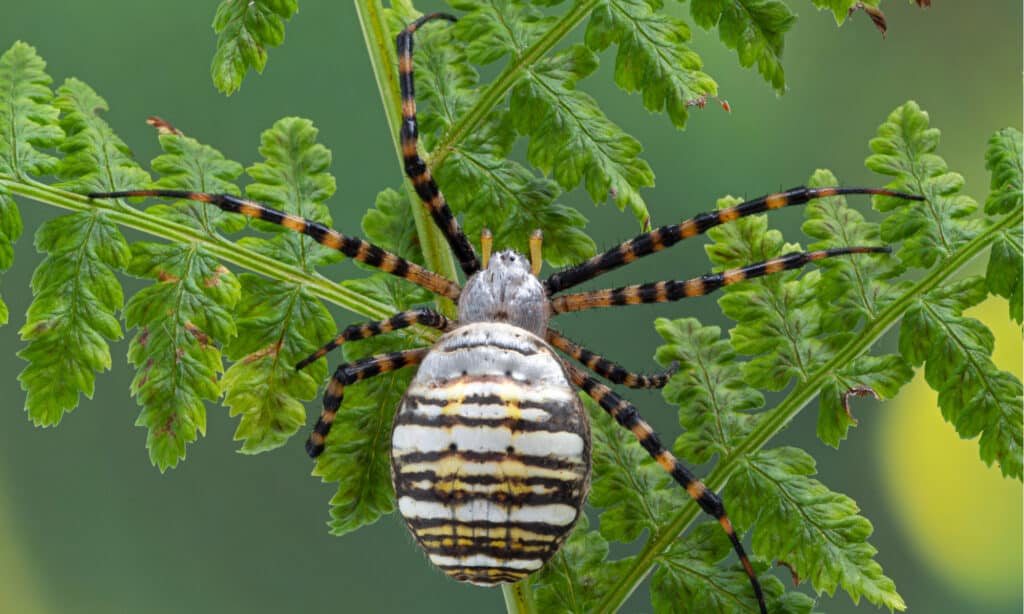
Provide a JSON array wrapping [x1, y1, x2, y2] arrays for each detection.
[[0, 0, 1022, 613]]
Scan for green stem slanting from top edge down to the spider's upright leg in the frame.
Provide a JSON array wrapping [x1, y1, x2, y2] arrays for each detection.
[[425, 0, 601, 167]]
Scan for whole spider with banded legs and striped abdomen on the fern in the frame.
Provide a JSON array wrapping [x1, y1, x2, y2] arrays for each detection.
[[89, 13, 923, 614]]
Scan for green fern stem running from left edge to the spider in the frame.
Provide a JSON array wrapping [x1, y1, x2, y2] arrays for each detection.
[[0, 173, 437, 349]]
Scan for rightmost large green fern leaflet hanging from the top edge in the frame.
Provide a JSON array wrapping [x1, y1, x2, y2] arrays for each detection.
[[690, 0, 797, 93]]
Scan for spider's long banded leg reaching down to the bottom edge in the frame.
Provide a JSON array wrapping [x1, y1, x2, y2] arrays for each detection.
[[563, 361, 768, 614]]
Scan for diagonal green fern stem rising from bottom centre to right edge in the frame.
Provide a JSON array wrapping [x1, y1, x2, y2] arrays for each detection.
[[597, 211, 1024, 612]]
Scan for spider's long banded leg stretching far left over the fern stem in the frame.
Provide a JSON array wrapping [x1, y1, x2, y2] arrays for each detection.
[[89, 189, 462, 300]]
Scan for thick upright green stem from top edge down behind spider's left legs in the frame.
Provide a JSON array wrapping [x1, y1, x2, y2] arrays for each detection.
[[355, 0, 459, 316]]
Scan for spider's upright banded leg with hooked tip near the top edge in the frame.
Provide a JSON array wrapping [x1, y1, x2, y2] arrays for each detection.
[[395, 13, 480, 277]]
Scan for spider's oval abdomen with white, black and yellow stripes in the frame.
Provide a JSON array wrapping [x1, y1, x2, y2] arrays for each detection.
[[391, 323, 590, 584]]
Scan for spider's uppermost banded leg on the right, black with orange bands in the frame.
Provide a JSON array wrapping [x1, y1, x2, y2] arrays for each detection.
[[544, 187, 925, 296]]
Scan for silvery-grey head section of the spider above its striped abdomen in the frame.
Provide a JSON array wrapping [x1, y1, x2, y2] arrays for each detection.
[[459, 250, 548, 338]]
